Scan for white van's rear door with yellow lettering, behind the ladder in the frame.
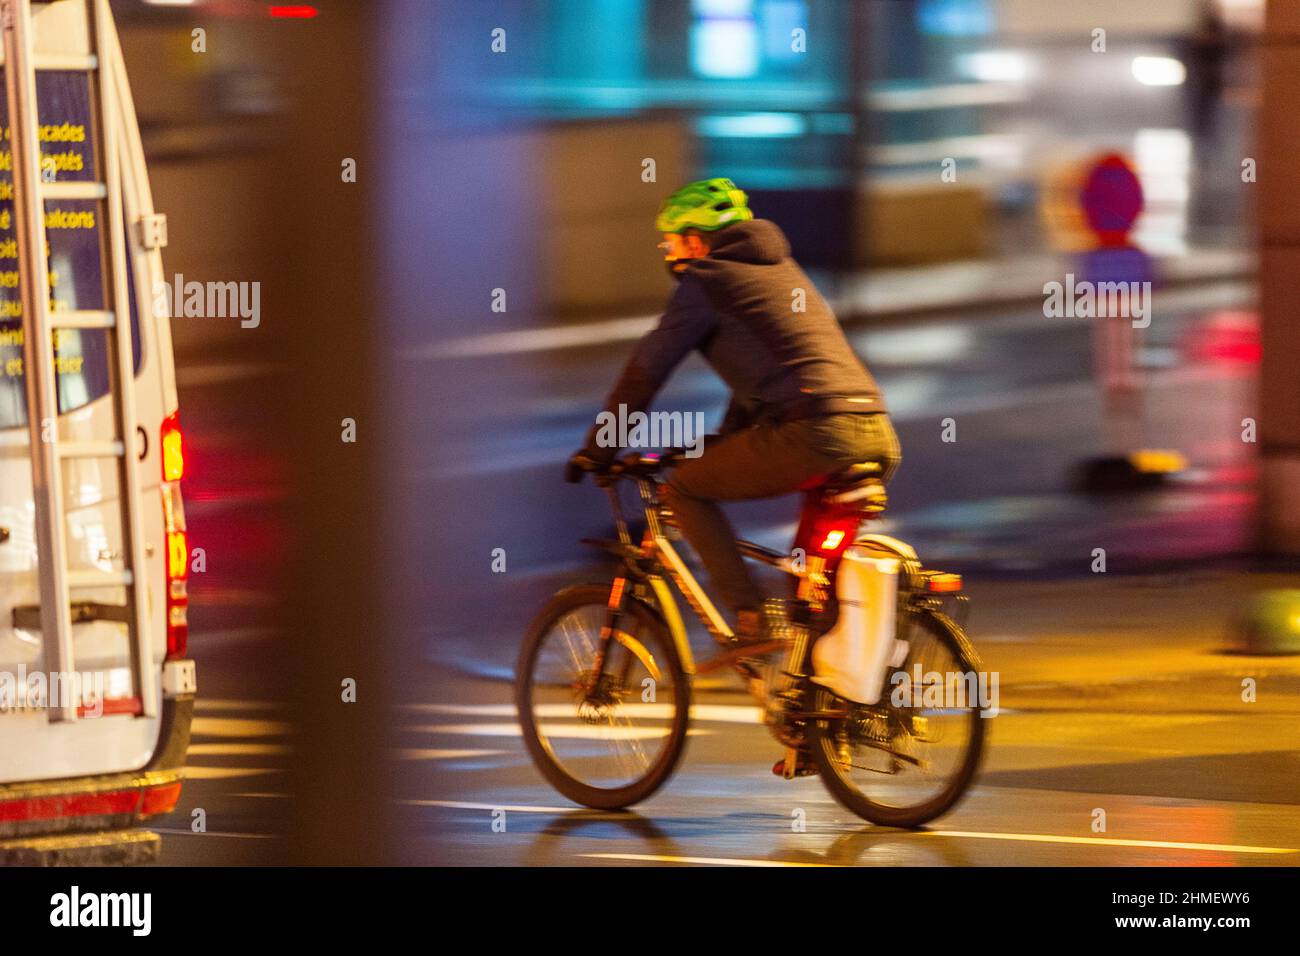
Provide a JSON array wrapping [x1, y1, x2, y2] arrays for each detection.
[[0, 0, 183, 784]]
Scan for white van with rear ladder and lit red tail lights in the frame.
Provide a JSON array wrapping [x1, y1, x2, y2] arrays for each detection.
[[0, 0, 195, 862]]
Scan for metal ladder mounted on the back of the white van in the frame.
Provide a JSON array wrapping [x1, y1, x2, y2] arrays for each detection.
[[0, 0, 159, 722]]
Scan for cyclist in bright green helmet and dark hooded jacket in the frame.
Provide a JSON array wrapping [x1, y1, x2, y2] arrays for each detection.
[[568, 178, 901, 764]]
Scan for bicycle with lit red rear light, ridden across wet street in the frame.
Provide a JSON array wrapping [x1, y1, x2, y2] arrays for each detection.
[[515, 454, 984, 827]]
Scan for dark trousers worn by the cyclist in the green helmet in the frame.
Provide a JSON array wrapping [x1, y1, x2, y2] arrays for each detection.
[[667, 412, 902, 610]]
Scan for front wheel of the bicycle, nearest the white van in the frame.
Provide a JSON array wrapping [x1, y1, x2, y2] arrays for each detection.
[[515, 584, 690, 809]]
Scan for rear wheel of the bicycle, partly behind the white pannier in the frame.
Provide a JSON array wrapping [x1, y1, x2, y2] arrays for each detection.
[[809, 609, 988, 827]]
